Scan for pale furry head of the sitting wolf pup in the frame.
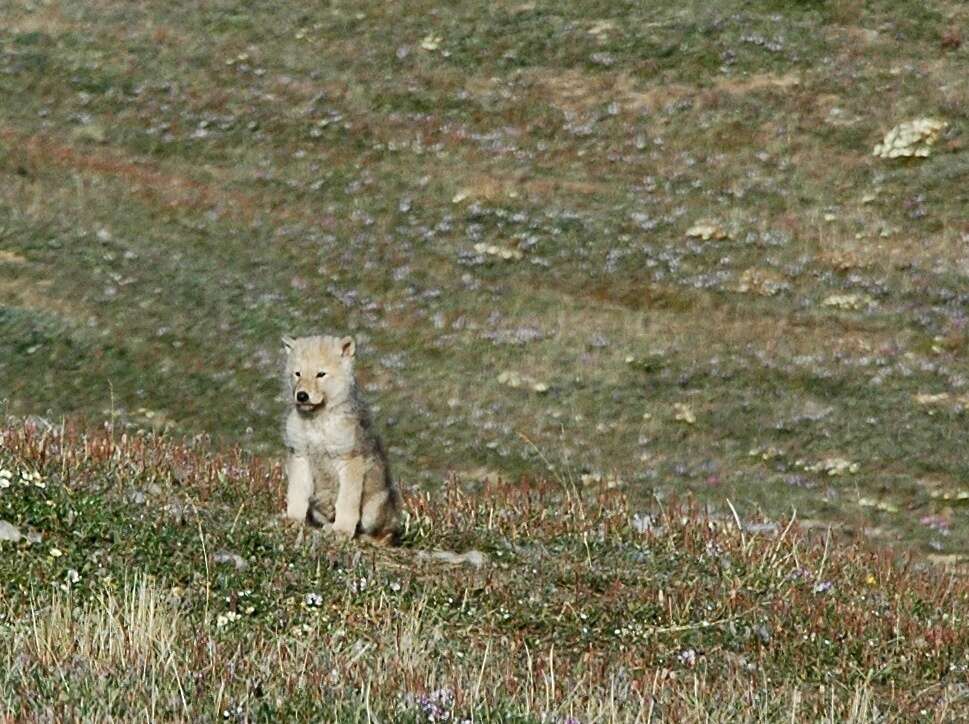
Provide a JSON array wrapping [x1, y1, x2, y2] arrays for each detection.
[[283, 336, 356, 413]]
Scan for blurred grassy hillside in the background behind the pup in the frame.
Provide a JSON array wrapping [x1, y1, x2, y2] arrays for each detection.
[[0, 0, 969, 555]]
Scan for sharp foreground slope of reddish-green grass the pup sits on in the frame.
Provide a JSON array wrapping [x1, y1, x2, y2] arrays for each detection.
[[0, 425, 969, 724]]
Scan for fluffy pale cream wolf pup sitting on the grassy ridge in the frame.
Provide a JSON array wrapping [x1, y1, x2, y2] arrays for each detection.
[[283, 336, 401, 544]]
